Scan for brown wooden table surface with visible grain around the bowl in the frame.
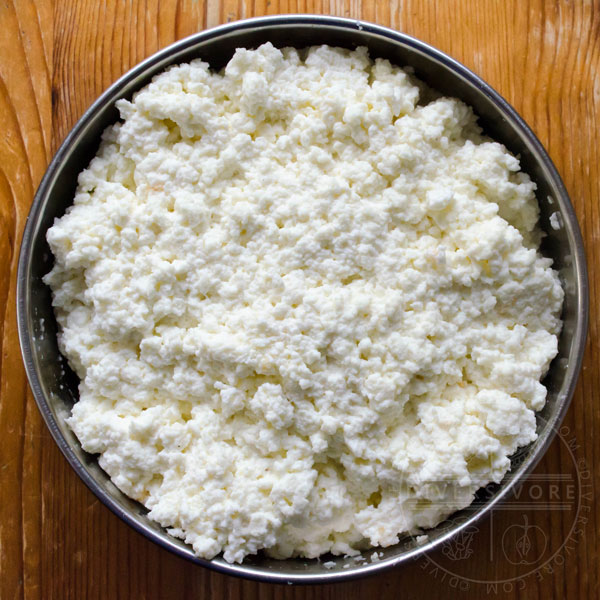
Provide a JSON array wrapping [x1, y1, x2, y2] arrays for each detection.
[[0, 0, 600, 600]]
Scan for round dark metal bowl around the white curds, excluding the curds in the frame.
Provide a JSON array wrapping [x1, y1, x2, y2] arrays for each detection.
[[17, 15, 588, 583]]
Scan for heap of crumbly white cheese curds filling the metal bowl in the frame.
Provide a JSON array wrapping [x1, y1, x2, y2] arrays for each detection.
[[45, 44, 563, 562]]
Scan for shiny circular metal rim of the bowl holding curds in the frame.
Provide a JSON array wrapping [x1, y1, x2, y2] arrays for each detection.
[[17, 14, 589, 584]]
